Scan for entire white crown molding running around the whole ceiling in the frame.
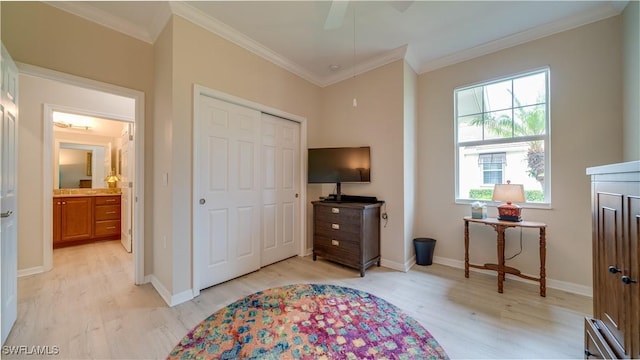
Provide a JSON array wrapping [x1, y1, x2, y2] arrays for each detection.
[[46, 1, 626, 87]]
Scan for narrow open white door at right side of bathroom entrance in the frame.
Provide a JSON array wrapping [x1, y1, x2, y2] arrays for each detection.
[[118, 124, 135, 252]]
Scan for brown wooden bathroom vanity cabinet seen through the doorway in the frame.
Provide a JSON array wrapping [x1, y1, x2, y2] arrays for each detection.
[[53, 194, 121, 248]]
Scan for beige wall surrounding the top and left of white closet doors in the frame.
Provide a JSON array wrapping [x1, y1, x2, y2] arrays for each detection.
[[154, 16, 319, 295]]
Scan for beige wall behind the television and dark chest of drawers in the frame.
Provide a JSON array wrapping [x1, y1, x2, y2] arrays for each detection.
[[318, 60, 405, 268]]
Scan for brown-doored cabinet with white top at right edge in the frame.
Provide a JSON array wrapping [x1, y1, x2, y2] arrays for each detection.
[[585, 161, 640, 359]]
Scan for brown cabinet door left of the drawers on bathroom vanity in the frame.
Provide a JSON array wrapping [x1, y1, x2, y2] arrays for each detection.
[[60, 197, 93, 242]]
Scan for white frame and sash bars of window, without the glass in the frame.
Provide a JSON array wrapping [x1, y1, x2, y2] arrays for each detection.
[[453, 66, 552, 209]]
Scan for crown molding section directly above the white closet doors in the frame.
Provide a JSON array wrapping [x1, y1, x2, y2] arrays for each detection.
[[170, 2, 322, 86]]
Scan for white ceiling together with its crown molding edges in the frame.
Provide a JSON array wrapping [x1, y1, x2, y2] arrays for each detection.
[[47, 0, 628, 86]]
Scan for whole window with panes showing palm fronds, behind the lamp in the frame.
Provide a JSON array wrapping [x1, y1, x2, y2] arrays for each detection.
[[454, 69, 551, 204]]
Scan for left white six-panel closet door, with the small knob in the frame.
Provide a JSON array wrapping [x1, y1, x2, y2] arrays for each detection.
[[194, 95, 261, 289]]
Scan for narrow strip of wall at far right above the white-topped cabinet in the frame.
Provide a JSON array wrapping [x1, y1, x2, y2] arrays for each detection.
[[622, 1, 640, 161]]
